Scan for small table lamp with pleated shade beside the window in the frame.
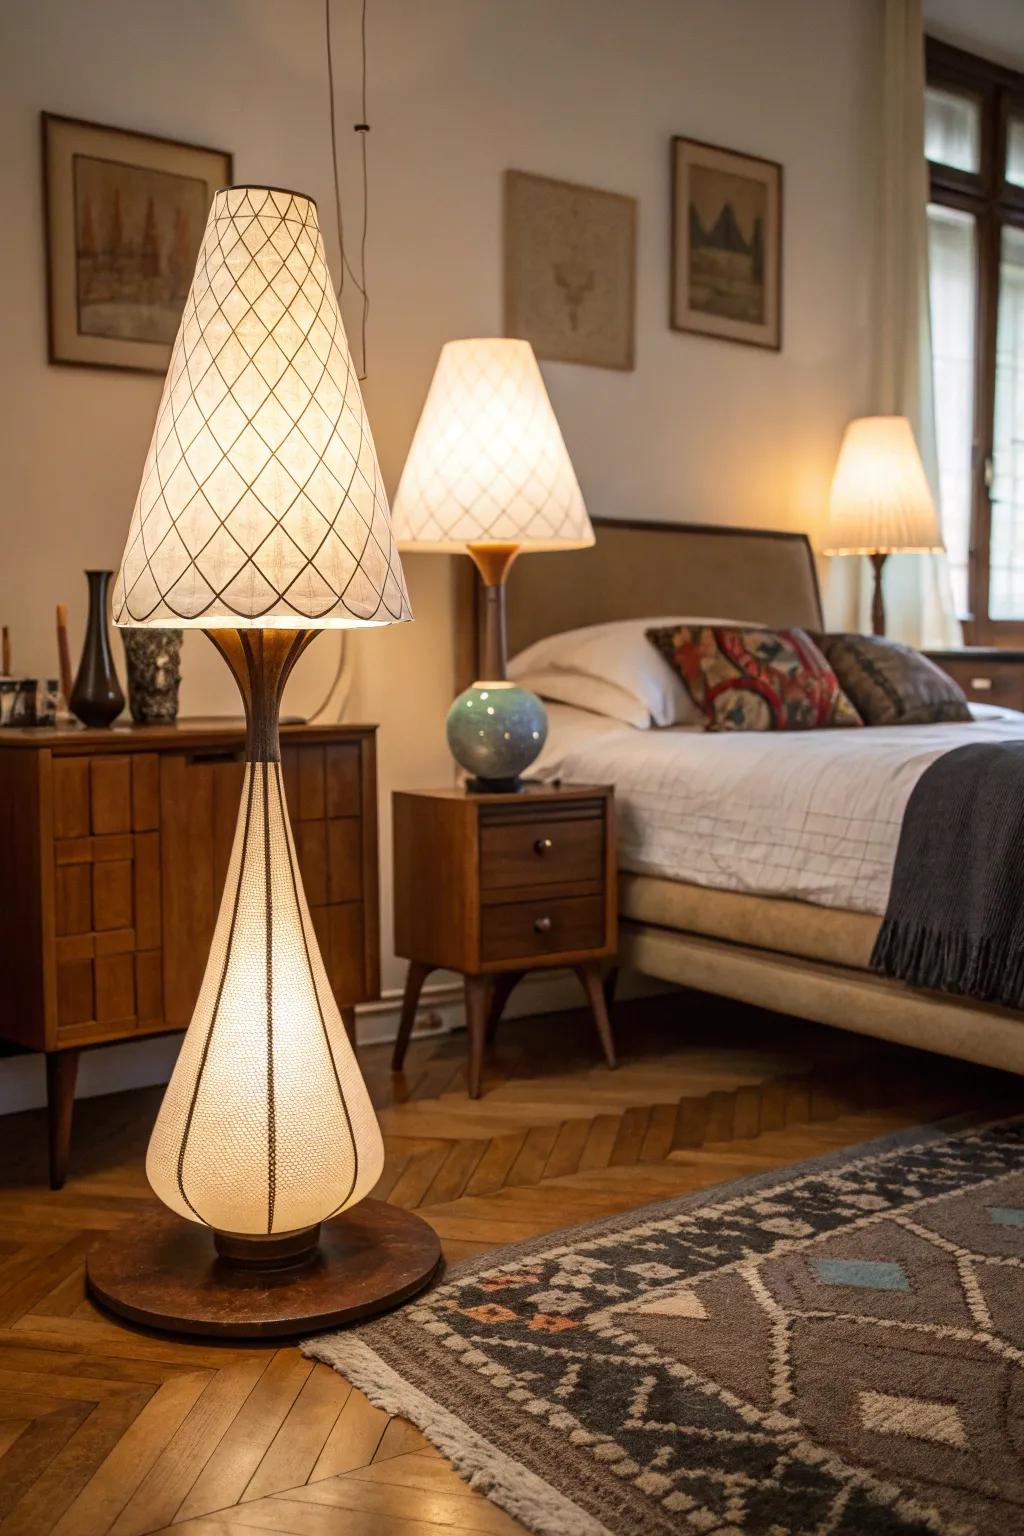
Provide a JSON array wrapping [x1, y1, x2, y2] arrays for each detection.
[[821, 416, 943, 634]]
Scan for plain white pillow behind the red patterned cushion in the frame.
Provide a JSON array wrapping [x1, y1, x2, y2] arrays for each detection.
[[508, 617, 754, 730]]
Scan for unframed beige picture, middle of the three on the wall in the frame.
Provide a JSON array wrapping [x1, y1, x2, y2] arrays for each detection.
[[505, 170, 637, 369]]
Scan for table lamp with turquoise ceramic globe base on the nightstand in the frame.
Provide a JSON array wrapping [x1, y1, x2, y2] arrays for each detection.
[[391, 336, 594, 791]]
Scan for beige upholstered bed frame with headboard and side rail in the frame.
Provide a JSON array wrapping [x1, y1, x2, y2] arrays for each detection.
[[457, 519, 1024, 1072]]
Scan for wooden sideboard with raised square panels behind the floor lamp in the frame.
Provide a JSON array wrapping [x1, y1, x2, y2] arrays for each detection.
[[0, 720, 381, 1189]]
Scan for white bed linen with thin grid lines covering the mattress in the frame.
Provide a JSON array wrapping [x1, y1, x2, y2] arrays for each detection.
[[530, 703, 1024, 915]]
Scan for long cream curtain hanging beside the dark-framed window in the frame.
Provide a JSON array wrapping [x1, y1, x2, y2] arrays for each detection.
[[860, 0, 963, 647]]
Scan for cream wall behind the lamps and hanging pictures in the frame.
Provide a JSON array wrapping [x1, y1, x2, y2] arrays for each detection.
[[0, 0, 880, 1112]]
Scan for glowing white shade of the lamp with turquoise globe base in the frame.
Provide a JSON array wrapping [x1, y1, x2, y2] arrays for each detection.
[[391, 336, 594, 553]]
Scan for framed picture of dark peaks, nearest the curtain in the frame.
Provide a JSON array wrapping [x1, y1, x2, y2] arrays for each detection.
[[669, 138, 783, 352]]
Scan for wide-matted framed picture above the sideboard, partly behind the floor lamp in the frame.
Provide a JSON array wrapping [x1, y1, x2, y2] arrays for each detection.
[[43, 112, 232, 373]]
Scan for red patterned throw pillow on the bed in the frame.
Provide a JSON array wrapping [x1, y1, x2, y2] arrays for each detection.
[[646, 625, 863, 731]]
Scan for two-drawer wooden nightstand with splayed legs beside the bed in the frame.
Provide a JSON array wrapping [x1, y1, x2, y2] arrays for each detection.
[[391, 783, 617, 1098]]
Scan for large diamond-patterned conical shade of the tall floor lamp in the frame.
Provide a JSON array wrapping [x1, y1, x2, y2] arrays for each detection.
[[114, 187, 411, 628]]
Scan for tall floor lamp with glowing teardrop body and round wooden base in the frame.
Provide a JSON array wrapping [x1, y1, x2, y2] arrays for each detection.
[[88, 187, 439, 1333]]
